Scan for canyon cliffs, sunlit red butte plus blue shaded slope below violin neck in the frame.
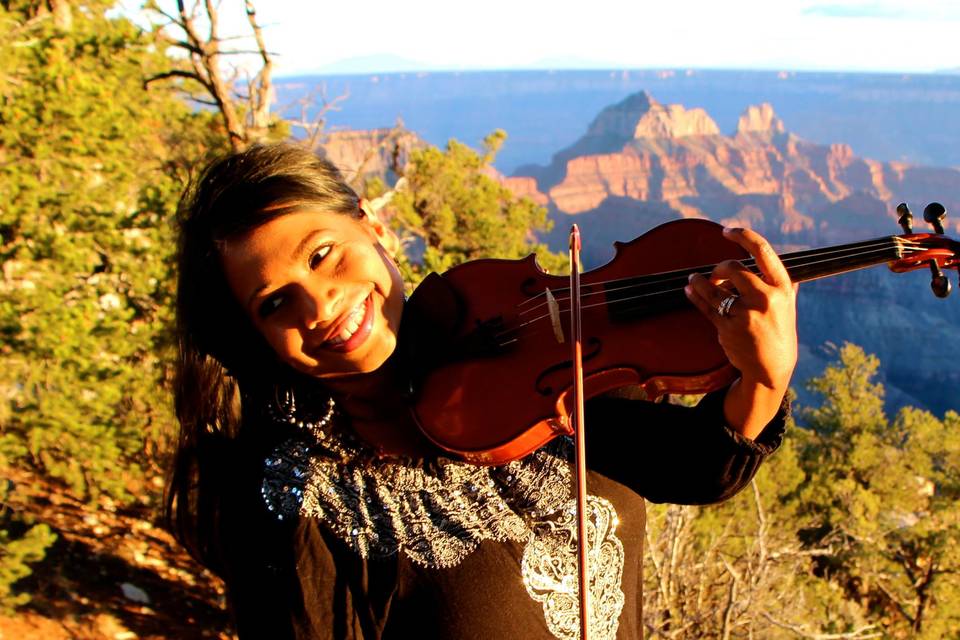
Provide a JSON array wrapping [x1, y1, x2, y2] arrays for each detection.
[[509, 93, 960, 412]]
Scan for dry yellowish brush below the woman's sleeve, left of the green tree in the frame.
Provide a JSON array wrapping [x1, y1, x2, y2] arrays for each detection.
[[643, 425, 877, 640]]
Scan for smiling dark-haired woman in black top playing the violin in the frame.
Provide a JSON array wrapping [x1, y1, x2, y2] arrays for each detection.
[[167, 145, 796, 639]]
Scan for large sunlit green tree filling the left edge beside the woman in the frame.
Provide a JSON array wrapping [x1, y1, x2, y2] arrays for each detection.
[[0, 0, 225, 608]]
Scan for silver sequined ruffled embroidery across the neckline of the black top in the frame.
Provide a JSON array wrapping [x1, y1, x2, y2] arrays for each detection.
[[261, 434, 570, 567]]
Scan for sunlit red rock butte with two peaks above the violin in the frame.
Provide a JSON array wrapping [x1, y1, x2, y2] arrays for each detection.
[[524, 92, 960, 244]]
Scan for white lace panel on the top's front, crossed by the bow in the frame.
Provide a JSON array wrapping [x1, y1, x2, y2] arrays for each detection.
[[520, 496, 624, 640]]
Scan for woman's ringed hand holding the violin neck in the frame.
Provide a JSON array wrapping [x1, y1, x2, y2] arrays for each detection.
[[685, 228, 797, 438]]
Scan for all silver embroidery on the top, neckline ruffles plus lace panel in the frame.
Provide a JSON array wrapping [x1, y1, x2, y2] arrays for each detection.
[[261, 422, 624, 640]]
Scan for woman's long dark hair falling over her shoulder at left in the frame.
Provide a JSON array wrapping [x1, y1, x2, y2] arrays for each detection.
[[164, 143, 361, 573]]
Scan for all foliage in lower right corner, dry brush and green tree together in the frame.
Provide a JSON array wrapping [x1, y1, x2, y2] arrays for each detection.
[[644, 344, 960, 639]]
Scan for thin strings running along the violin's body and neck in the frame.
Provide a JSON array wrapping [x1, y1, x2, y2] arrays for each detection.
[[495, 239, 921, 346]]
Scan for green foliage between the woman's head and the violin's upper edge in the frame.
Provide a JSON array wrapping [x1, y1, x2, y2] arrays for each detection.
[[376, 130, 567, 285]]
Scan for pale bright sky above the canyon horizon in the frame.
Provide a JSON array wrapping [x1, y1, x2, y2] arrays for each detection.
[[141, 0, 960, 76]]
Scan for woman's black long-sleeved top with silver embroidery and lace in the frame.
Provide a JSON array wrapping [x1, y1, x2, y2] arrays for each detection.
[[222, 392, 786, 640]]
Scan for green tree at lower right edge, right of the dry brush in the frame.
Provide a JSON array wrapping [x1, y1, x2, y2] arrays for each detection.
[[801, 344, 960, 638]]
